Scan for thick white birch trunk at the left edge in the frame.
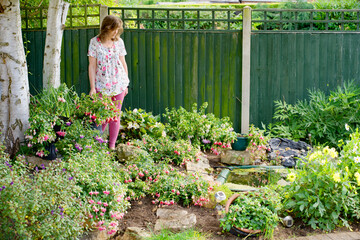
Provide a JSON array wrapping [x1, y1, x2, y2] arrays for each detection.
[[0, 0, 29, 155]]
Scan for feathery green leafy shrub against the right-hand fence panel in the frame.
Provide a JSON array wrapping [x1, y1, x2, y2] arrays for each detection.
[[269, 82, 360, 147]]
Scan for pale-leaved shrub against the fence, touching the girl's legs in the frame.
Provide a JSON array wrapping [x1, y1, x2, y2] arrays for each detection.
[[119, 108, 164, 143]]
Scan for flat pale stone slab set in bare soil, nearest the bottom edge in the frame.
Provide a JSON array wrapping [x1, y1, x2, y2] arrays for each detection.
[[154, 208, 196, 232]]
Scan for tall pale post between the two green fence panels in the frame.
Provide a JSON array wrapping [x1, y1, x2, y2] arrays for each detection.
[[241, 6, 251, 134]]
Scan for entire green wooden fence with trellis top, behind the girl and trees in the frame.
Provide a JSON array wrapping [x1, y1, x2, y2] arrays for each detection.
[[24, 8, 360, 131]]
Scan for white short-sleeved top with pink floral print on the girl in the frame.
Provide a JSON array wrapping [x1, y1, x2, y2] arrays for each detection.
[[88, 37, 129, 96]]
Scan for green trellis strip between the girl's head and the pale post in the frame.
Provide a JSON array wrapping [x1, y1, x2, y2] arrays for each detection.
[[108, 7, 242, 31]]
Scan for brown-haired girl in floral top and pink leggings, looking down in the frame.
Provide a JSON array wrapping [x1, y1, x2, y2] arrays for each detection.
[[88, 15, 129, 150]]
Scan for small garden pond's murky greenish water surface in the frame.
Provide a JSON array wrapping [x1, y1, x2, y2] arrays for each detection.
[[226, 167, 289, 187]]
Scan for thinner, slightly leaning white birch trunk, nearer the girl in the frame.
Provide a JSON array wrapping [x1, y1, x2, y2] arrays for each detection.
[[43, 0, 69, 88]]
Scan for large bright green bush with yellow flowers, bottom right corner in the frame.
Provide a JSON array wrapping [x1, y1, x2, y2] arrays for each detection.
[[284, 130, 360, 230]]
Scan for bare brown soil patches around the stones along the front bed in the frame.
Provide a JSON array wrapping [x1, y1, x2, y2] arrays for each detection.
[[112, 154, 360, 240]]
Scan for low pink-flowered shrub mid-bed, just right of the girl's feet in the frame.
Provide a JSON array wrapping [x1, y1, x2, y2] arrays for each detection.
[[129, 135, 201, 165]]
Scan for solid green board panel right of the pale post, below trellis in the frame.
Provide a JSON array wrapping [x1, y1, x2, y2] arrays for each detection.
[[250, 32, 360, 126]]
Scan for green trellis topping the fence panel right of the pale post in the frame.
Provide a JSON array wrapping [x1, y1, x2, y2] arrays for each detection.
[[252, 9, 360, 32]]
